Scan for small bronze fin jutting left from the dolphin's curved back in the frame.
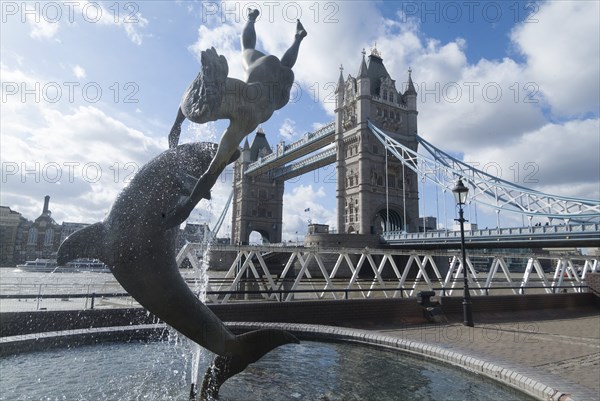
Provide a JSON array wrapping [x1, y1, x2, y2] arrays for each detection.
[[57, 223, 107, 266]]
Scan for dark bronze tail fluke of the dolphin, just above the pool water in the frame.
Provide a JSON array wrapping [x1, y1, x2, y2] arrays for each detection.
[[200, 329, 300, 400]]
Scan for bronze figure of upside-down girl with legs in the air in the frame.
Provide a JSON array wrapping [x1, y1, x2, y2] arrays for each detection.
[[167, 10, 307, 227]]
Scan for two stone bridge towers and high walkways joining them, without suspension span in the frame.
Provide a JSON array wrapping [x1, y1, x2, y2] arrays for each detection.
[[231, 49, 419, 244]]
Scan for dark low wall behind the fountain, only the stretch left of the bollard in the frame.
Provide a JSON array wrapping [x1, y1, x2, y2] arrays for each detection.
[[0, 299, 426, 337]]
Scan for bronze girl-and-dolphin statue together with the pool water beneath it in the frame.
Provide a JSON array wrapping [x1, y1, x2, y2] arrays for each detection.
[[0, 10, 536, 400]]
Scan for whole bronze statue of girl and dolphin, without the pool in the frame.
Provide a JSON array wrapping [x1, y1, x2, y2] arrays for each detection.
[[53, 10, 306, 398]]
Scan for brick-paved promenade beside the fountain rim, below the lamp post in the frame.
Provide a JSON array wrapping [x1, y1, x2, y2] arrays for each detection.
[[375, 310, 600, 401]]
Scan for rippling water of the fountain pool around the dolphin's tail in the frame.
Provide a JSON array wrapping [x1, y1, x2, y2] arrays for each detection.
[[0, 341, 533, 401]]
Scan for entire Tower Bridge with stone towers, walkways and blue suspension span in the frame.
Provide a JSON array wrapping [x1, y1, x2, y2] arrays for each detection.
[[226, 49, 600, 249]]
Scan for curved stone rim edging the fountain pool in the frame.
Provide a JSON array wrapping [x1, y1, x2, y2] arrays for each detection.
[[0, 322, 574, 401]]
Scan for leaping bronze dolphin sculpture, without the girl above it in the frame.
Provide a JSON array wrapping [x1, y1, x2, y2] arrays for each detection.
[[57, 143, 299, 396]]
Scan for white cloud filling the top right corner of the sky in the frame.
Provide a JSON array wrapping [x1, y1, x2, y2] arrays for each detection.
[[512, 1, 600, 116]]
